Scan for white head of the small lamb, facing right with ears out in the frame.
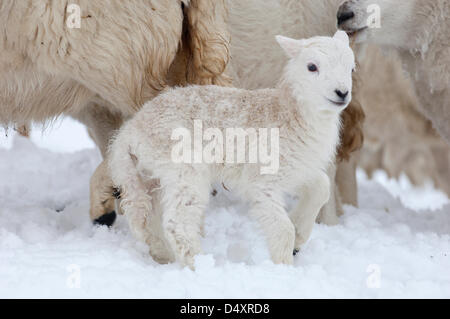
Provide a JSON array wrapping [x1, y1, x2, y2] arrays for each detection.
[[277, 31, 355, 112]]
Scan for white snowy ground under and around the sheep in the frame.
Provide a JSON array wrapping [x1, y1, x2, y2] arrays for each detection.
[[0, 121, 450, 298]]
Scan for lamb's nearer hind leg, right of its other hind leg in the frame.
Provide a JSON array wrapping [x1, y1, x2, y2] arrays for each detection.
[[160, 168, 210, 268]]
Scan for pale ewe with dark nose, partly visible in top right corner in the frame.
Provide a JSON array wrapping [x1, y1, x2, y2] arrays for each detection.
[[338, 0, 450, 143]]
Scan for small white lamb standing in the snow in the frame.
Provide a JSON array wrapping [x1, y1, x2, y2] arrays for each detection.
[[110, 31, 355, 267]]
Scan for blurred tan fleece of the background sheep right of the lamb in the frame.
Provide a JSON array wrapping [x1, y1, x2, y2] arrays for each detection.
[[357, 45, 450, 196]]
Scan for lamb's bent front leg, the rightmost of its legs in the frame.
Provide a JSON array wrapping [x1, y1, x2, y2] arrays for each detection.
[[291, 172, 330, 252]]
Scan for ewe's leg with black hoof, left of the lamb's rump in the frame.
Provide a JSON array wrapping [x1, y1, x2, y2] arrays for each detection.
[[72, 104, 124, 226]]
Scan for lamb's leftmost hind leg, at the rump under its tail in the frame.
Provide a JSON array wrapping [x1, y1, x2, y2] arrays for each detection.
[[107, 142, 173, 263]]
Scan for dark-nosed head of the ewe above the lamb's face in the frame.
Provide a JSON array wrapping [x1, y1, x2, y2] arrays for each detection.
[[337, 0, 414, 47]]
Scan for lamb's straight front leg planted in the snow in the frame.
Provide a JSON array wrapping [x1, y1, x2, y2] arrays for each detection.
[[246, 189, 295, 265]]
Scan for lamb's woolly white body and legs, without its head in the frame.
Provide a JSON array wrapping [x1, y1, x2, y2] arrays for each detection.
[[110, 87, 339, 266]]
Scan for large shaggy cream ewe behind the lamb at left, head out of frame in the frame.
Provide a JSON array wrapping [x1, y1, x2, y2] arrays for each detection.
[[0, 0, 231, 219]]
